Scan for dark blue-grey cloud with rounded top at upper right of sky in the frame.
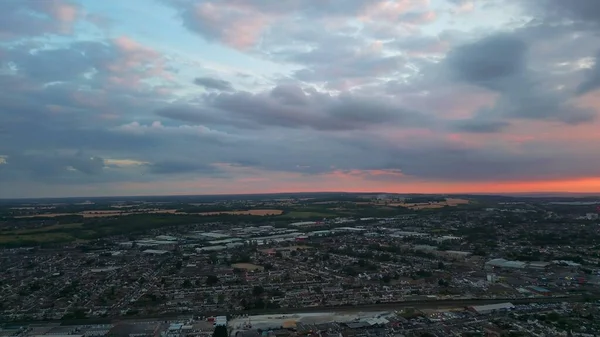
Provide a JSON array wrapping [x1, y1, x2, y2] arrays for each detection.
[[445, 33, 596, 126]]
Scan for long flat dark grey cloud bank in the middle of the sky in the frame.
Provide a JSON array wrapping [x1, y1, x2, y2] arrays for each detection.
[[157, 85, 427, 131]]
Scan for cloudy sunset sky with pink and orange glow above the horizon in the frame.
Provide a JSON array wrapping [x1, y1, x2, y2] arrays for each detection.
[[0, 0, 600, 198]]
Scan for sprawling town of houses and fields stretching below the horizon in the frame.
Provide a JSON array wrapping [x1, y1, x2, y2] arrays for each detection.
[[0, 195, 600, 336]]
